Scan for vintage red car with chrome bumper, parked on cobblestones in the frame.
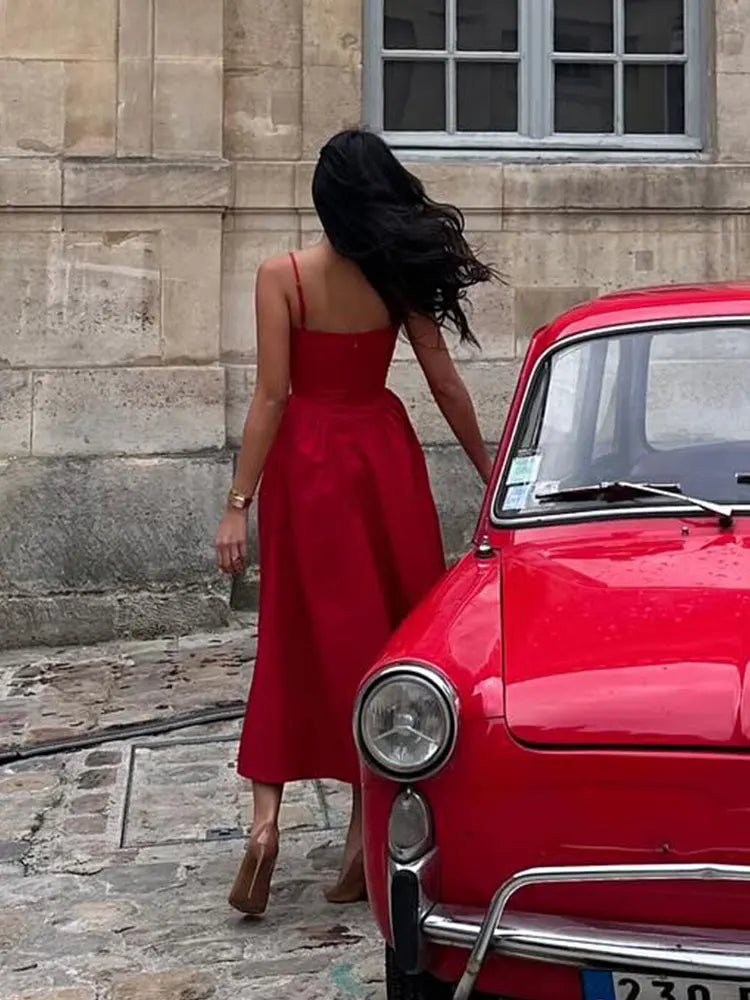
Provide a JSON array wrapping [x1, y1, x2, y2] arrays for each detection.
[[355, 285, 750, 1000]]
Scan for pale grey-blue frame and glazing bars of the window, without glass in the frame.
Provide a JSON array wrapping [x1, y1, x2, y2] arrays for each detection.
[[363, 0, 711, 153]]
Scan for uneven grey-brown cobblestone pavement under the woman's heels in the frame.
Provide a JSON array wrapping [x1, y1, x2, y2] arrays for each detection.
[[0, 628, 383, 1000]]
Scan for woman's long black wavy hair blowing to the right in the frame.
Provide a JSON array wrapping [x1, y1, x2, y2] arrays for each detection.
[[313, 129, 498, 344]]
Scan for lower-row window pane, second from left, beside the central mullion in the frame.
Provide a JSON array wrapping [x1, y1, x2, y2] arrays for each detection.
[[456, 62, 518, 132]]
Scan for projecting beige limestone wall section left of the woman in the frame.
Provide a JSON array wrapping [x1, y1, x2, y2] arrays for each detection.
[[0, 0, 232, 646]]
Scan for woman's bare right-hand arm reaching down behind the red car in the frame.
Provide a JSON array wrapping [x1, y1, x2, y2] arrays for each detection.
[[407, 316, 492, 483]]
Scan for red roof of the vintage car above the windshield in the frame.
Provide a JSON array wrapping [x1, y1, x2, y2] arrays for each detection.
[[532, 281, 750, 354]]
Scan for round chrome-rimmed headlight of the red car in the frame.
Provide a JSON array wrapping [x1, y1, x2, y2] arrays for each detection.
[[355, 664, 458, 781]]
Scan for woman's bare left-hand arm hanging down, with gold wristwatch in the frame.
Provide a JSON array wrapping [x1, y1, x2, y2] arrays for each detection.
[[216, 260, 290, 573]]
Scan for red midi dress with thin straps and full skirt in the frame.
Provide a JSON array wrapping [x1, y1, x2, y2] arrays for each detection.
[[238, 254, 445, 784]]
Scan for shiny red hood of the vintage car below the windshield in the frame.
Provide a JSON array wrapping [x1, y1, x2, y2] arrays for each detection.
[[502, 519, 750, 749]]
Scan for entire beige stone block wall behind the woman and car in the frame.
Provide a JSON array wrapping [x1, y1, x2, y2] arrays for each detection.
[[0, 0, 750, 646]]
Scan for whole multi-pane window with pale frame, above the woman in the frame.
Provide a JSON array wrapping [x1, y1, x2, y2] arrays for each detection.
[[365, 0, 706, 151]]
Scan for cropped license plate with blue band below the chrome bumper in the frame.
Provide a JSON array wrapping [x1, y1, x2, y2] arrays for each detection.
[[583, 972, 750, 1000]]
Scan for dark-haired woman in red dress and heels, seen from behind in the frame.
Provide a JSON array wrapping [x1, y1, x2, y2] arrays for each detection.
[[216, 130, 500, 915]]
